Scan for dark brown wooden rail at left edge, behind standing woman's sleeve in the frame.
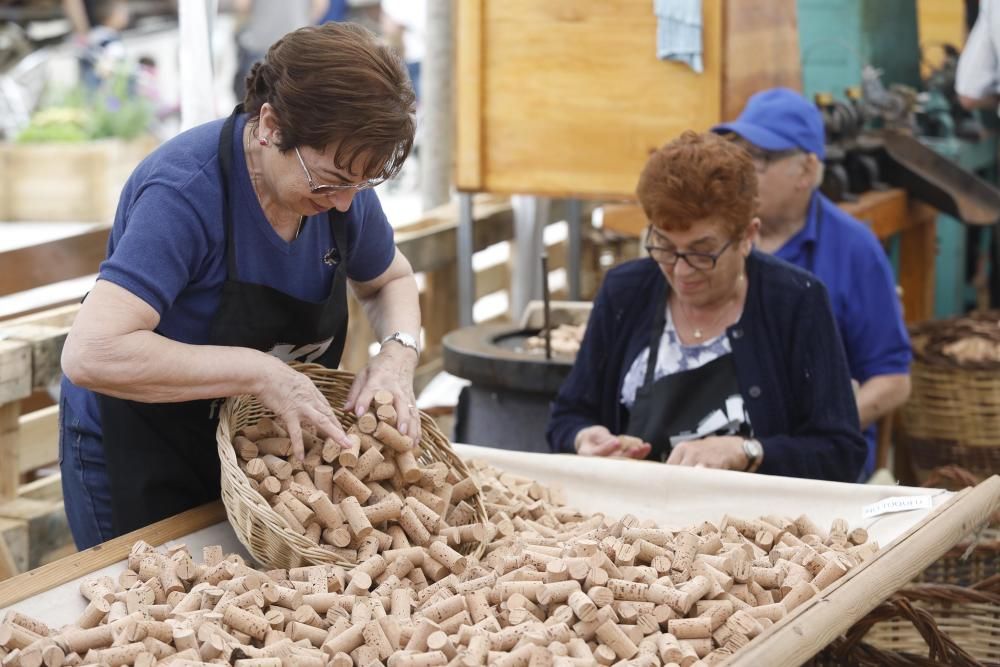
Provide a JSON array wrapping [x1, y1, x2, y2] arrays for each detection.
[[0, 231, 110, 296]]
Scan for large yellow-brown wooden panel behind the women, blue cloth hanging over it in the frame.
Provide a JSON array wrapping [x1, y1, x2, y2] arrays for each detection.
[[455, 0, 801, 198]]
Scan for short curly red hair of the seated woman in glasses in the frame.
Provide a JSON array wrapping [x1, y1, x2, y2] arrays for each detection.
[[636, 131, 757, 238]]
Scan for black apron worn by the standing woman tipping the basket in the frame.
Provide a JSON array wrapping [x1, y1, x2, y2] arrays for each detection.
[[98, 106, 347, 535]]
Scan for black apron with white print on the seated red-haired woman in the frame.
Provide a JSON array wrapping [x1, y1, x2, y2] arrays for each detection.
[[625, 281, 752, 461]]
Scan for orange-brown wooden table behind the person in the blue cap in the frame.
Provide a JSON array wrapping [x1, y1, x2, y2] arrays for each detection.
[[604, 188, 937, 323]]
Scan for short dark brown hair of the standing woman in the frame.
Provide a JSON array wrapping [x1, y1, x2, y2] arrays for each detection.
[[243, 22, 416, 178]]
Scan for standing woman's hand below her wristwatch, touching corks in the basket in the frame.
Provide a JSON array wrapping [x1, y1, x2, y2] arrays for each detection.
[[344, 344, 420, 442]]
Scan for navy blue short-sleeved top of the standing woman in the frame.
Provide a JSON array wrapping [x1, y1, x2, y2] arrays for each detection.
[[62, 115, 395, 435]]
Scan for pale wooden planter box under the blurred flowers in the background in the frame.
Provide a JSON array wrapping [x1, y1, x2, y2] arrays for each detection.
[[0, 137, 157, 222]]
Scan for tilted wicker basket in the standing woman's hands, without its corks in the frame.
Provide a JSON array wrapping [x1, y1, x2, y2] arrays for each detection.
[[216, 363, 487, 568]]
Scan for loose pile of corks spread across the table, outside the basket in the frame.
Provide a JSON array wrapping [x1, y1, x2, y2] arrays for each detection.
[[0, 434, 877, 667]]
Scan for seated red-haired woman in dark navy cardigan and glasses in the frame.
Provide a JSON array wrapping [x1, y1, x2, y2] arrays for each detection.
[[548, 132, 866, 481]]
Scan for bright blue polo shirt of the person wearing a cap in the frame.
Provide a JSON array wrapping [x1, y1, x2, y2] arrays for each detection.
[[775, 191, 912, 477]]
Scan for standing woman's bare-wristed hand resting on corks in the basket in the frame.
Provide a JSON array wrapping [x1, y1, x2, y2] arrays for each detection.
[[256, 357, 351, 460]]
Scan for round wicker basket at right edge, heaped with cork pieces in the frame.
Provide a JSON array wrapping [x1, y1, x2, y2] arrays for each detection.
[[898, 311, 1000, 482]]
